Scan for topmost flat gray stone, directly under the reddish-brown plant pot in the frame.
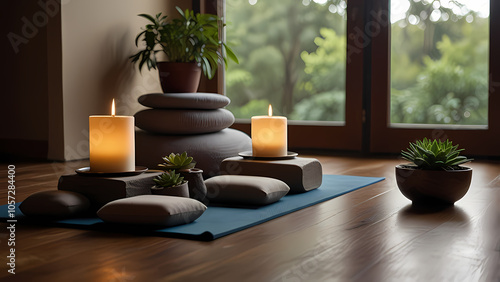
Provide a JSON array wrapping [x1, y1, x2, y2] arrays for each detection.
[[138, 93, 231, 110]]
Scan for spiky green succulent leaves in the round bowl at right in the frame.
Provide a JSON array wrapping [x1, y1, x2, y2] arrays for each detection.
[[401, 138, 472, 170]]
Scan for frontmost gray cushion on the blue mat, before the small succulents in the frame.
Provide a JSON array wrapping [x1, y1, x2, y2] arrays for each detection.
[[97, 195, 207, 226]]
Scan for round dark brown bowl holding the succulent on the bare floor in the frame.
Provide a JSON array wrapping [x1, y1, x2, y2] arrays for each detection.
[[396, 165, 472, 204]]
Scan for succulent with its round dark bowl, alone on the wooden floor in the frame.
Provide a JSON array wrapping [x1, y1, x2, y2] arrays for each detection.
[[396, 138, 472, 204]]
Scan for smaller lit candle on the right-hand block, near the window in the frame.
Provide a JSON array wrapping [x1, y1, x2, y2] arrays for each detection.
[[252, 105, 288, 157]]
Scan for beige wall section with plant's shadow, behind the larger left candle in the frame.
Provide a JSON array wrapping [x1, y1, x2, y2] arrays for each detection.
[[55, 0, 190, 160]]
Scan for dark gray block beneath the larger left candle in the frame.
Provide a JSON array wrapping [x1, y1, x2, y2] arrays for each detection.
[[57, 172, 161, 210]]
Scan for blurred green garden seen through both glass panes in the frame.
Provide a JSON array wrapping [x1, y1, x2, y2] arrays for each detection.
[[226, 0, 489, 125]]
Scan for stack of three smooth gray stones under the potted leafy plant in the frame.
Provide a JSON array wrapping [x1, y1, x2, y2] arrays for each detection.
[[135, 93, 252, 178]]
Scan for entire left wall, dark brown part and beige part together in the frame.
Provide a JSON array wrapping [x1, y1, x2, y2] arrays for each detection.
[[0, 0, 191, 160]]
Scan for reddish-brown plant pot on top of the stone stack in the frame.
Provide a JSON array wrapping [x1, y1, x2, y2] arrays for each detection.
[[157, 62, 201, 93]]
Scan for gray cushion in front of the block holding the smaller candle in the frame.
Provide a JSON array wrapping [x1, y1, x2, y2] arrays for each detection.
[[205, 175, 290, 205]]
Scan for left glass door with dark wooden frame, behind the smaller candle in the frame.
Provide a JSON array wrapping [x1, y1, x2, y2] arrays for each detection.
[[225, 0, 362, 150]]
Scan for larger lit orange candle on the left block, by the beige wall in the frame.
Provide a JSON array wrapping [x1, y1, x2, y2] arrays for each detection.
[[89, 99, 135, 172]]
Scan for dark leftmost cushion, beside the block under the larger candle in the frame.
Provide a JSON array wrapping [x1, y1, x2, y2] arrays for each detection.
[[19, 190, 90, 218]]
